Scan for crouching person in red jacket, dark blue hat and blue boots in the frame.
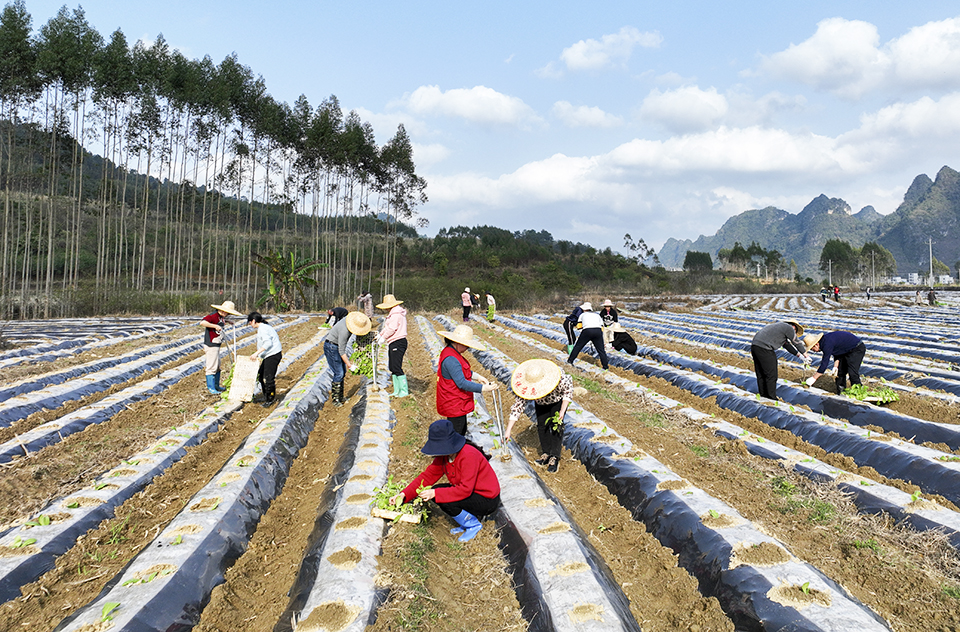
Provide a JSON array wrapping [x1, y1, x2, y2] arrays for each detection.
[[390, 419, 500, 542]]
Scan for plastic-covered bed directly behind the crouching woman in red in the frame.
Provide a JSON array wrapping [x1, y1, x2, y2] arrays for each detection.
[[417, 316, 640, 632]]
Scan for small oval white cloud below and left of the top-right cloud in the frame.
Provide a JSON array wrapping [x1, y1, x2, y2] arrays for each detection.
[[640, 86, 728, 134]]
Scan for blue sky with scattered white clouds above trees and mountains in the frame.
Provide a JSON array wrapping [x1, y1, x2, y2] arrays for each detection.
[[20, 0, 960, 252]]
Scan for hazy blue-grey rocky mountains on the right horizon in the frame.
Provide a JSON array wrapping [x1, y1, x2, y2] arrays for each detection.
[[658, 166, 960, 278]]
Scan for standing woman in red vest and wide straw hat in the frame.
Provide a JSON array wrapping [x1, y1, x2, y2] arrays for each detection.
[[437, 325, 497, 436]]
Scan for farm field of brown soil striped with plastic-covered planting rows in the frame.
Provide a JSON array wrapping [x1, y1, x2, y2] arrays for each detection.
[[0, 293, 960, 632]]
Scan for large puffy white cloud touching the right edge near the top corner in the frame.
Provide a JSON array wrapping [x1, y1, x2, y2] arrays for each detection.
[[760, 18, 960, 99]]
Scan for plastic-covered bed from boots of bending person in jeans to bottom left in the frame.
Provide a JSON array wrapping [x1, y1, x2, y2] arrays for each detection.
[[57, 358, 330, 632]]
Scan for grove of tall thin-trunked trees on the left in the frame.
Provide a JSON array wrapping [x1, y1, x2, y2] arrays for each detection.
[[0, 0, 426, 318]]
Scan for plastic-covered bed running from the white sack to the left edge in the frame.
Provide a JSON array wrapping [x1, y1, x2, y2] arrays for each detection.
[[0, 332, 326, 603]]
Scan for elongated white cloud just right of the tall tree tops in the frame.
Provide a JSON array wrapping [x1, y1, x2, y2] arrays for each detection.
[[401, 86, 542, 126]]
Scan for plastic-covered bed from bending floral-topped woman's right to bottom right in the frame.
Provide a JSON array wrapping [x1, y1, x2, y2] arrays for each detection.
[[464, 321, 889, 632]]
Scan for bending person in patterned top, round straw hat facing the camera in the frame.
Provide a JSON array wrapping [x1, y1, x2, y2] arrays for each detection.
[[503, 358, 573, 472]]
